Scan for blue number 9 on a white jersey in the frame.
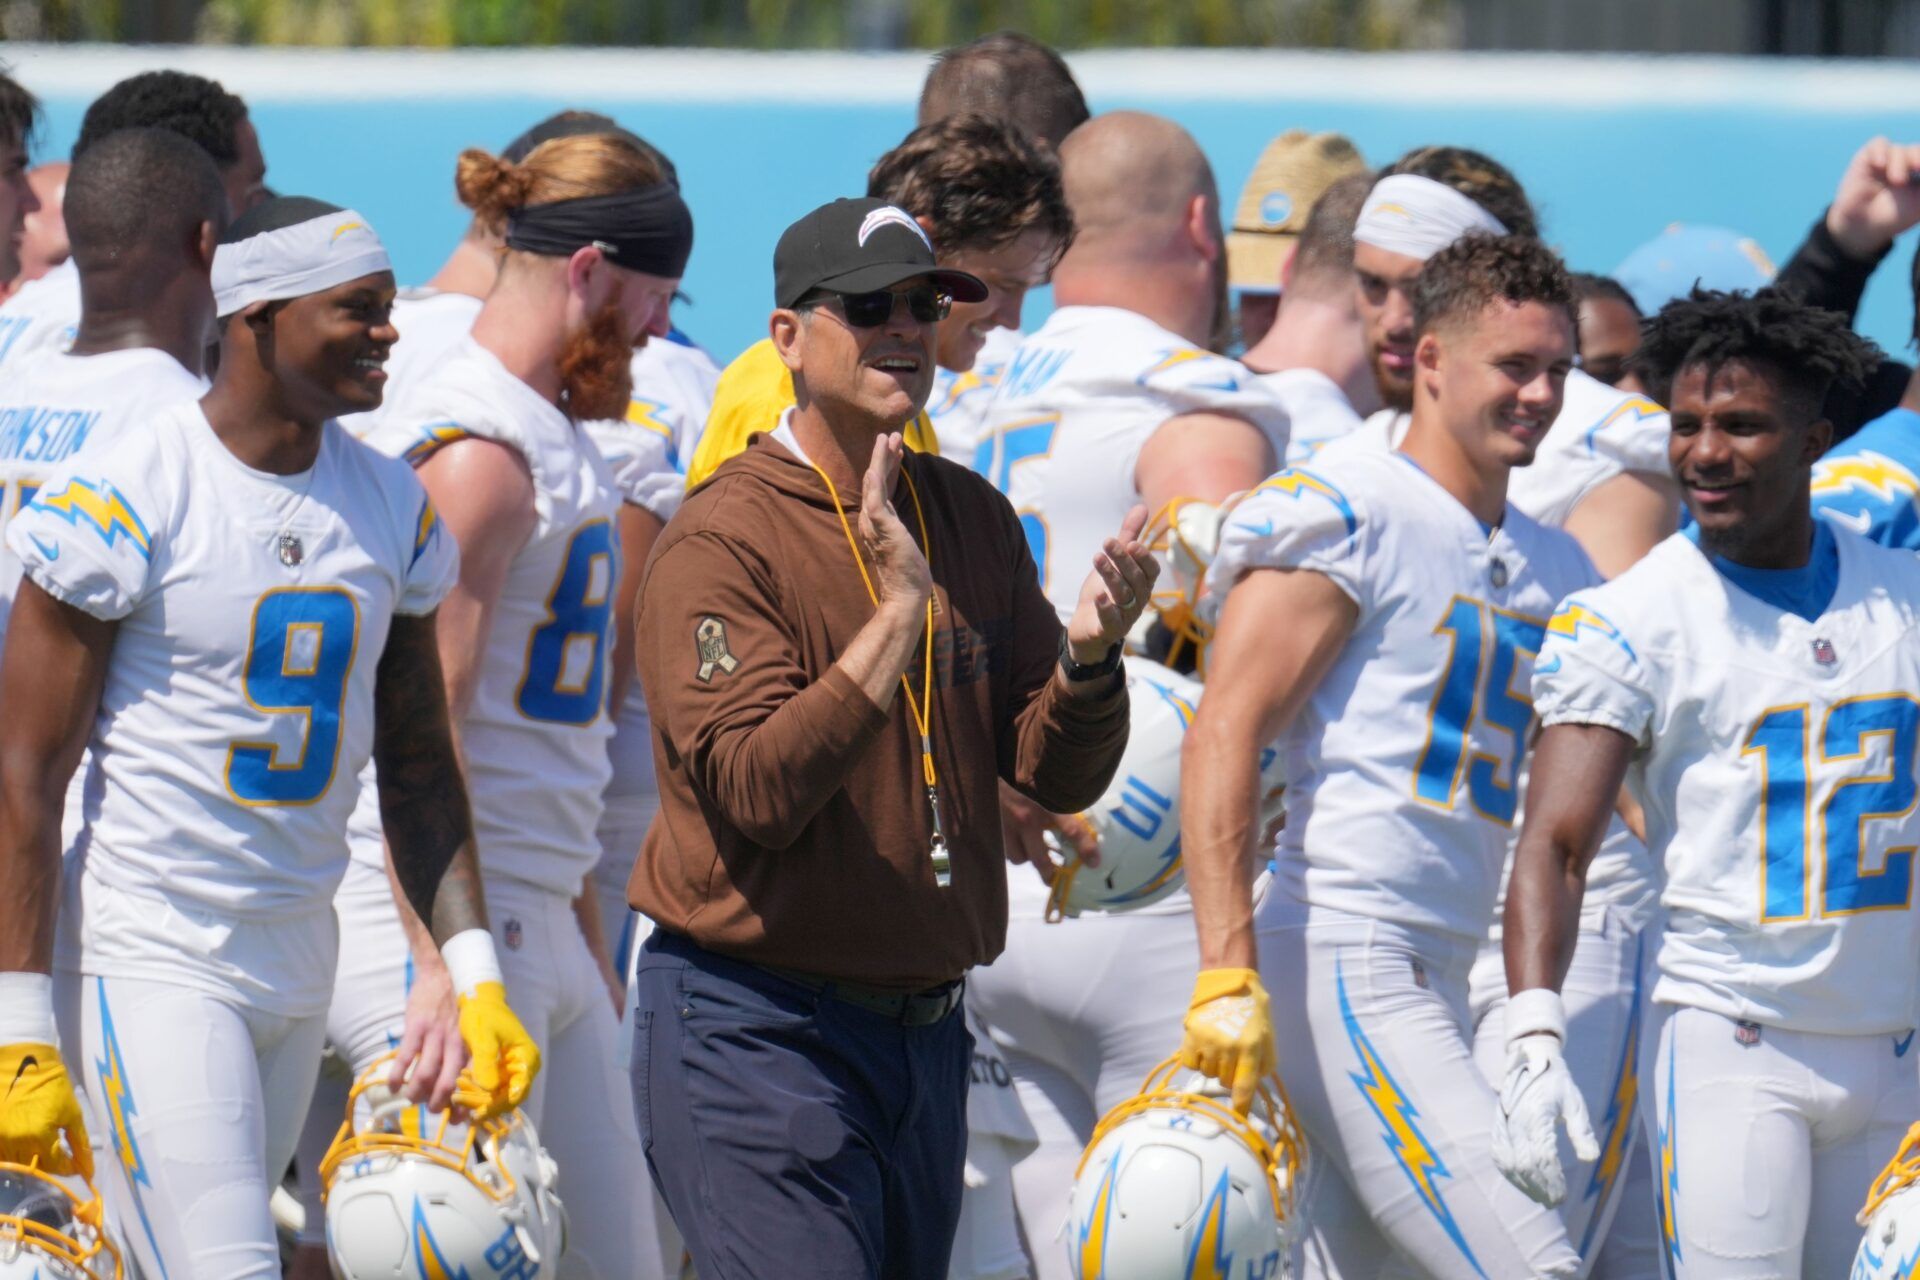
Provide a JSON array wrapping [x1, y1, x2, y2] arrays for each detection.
[[227, 587, 359, 804]]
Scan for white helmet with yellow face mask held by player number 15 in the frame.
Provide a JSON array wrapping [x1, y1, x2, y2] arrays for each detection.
[[1068, 1057, 1306, 1280]]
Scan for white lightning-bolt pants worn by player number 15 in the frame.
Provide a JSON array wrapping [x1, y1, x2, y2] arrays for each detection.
[[1260, 898, 1580, 1280]]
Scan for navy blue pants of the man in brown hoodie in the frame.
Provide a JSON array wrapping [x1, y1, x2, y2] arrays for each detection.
[[634, 931, 973, 1280]]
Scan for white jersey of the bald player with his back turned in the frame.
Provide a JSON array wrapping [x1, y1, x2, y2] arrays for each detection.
[[975, 307, 1286, 618]]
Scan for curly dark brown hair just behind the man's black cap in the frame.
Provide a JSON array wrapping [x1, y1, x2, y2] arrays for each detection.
[[866, 111, 1073, 261]]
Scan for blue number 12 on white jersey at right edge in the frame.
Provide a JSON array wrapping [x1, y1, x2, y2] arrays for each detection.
[[1740, 693, 1920, 925]]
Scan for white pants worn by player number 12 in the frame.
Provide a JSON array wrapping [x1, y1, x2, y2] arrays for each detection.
[[1642, 1004, 1920, 1280]]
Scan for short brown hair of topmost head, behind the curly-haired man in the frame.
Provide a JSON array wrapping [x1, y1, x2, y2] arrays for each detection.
[[920, 31, 1091, 148]]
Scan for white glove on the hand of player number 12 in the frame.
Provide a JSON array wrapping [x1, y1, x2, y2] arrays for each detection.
[[1494, 988, 1599, 1207]]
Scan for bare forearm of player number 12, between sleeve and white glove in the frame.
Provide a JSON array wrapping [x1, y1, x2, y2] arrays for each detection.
[[1503, 723, 1634, 994]]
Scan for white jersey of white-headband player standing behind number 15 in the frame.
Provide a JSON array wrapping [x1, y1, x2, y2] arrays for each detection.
[[1342, 368, 1672, 528]]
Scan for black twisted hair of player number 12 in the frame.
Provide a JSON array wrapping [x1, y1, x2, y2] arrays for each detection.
[[1632, 286, 1882, 416]]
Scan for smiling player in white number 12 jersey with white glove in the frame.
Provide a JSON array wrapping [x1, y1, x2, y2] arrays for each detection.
[[1498, 292, 1920, 1280]]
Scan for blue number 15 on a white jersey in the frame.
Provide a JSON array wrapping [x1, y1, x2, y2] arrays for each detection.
[[1413, 595, 1546, 825]]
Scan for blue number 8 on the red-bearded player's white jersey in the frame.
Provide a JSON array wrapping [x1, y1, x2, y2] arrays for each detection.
[[515, 520, 616, 725]]
